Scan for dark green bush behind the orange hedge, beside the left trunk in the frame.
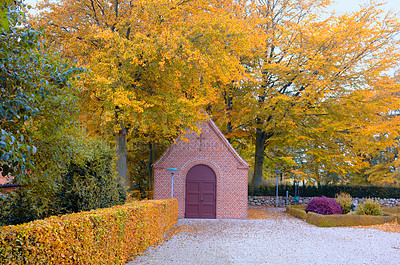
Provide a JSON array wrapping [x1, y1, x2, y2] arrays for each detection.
[[56, 141, 126, 213]]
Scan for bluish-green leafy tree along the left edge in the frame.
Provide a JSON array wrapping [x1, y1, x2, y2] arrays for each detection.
[[0, 1, 78, 178]]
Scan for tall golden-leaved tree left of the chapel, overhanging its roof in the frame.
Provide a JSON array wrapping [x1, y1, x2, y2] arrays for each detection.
[[35, 0, 256, 185]]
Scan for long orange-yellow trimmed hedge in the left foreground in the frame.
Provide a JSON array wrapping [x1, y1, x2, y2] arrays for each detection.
[[0, 199, 178, 264]]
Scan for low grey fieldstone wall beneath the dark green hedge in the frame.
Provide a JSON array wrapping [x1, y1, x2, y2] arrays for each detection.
[[249, 196, 400, 207]]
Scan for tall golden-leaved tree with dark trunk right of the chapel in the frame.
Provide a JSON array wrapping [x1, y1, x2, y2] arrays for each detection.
[[223, 0, 400, 188]]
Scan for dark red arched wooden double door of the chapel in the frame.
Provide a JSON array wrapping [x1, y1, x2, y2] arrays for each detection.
[[185, 165, 217, 218]]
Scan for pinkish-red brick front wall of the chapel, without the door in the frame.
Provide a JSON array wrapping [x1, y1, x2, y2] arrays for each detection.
[[154, 118, 249, 219]]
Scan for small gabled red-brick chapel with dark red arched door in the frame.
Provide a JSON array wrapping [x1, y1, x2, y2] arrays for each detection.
[[154, 119, 250, 219]]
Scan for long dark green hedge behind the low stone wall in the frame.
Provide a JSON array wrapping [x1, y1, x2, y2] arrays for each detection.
[[249, 185, 400, 199]]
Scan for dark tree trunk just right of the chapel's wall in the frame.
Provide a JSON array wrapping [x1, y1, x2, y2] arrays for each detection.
[[251, 128, 265, 189]]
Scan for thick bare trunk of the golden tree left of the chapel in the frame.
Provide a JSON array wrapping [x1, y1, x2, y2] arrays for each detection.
[[116, 124, 131, 189]]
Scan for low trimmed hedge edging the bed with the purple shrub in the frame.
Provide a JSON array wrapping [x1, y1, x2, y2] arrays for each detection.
[[286, 205, 396, 227]]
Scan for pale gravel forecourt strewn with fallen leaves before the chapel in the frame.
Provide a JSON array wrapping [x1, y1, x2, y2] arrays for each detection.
[[127, 208, 400, 265]]
